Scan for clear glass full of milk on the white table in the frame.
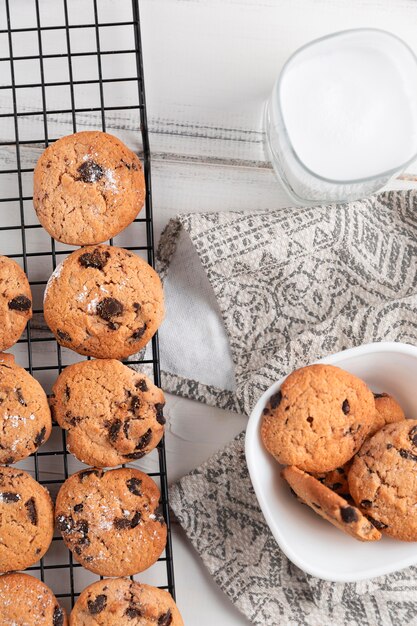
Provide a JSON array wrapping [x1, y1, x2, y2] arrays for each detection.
[[265, 28, 417, 203]]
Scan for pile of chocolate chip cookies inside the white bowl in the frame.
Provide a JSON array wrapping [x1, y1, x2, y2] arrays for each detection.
[[261, 365, 417, 541]]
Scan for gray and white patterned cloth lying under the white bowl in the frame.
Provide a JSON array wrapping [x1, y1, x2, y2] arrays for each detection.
[[159, 191, 417, 626]]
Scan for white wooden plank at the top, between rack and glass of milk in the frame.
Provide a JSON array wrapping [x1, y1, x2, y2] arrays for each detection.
[[141, 0, 417, 168]]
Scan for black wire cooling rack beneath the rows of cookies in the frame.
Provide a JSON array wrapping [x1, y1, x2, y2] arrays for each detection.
[[0, 0, 175, 609]]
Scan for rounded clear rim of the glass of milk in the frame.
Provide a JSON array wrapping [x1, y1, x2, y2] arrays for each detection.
[[273, 27, 417, 185]]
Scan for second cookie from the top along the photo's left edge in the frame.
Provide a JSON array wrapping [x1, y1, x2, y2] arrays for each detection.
[[0, 353, 52, 465]]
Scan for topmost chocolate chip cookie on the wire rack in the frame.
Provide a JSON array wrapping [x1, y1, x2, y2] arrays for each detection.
[[33, 131, 145, 246]]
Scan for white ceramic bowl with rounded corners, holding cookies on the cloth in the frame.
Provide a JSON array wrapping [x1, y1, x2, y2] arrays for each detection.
[[245, 343, 417, 582]]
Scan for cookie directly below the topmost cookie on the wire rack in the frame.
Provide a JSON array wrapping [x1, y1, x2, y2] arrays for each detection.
[[44, 245, 164, 359]]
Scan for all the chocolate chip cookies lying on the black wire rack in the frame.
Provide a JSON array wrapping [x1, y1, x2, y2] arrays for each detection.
[[0, 131, 183, 626]]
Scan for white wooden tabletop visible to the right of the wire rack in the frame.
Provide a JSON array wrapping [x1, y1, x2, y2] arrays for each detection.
[[141, 0, 417, 626]]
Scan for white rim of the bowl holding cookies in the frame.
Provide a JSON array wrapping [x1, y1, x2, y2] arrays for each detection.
[[245, 341, 417, 583]]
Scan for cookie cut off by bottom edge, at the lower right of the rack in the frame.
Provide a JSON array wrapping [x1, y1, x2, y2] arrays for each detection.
[[70, 578, 184, 626]]
